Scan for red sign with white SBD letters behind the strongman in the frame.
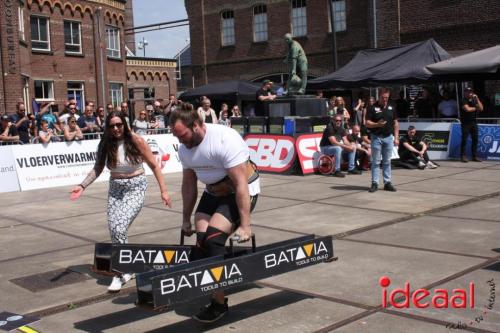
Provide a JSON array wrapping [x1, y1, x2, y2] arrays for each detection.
[[245, 134, 295, 173]]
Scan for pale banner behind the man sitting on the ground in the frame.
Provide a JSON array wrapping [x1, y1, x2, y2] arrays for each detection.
[[399, 122, 452, 160]]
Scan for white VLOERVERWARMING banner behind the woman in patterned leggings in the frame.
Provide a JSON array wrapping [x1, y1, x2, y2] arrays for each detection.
[[11, 134, 182, 191]]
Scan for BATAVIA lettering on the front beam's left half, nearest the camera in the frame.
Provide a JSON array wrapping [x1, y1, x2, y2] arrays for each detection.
[[160, 263, 243, 295]]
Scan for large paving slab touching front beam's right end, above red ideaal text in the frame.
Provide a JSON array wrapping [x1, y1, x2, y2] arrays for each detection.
[[263, 240, 484, 306]]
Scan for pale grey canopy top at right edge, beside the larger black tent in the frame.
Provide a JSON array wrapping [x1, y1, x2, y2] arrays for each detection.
[[426, 45, 500, 81]]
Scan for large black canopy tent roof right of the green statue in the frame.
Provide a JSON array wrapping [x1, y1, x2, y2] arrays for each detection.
[[308, 39, 450, 89]]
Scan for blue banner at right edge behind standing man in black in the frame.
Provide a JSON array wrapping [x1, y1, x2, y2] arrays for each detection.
[[449, 124, 500, 161]]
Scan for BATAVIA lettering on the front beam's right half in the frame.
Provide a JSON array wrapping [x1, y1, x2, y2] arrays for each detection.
[[264, 242, 328, 269]]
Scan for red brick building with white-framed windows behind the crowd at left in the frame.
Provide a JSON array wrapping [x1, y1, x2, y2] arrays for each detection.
[[0, 0, 176, 114]]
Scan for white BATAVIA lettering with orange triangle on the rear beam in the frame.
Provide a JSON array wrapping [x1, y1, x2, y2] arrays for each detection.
[[118, 249, 189, 269]]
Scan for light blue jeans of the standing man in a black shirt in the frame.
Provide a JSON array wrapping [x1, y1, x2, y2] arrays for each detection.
[[371, 134, 394, 184]]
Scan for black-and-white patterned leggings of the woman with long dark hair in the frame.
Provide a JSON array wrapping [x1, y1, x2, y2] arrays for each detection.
[[108, 174, 148, 244]]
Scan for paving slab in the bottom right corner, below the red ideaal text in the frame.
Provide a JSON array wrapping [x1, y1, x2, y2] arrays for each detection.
[[397, 261, 500, 332]]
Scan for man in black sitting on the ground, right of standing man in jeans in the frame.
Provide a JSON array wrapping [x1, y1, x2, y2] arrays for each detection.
[[398, 126, 437, 169]]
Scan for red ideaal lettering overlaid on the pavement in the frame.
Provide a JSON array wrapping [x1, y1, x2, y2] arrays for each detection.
[[379, 276, 474, 309]]
